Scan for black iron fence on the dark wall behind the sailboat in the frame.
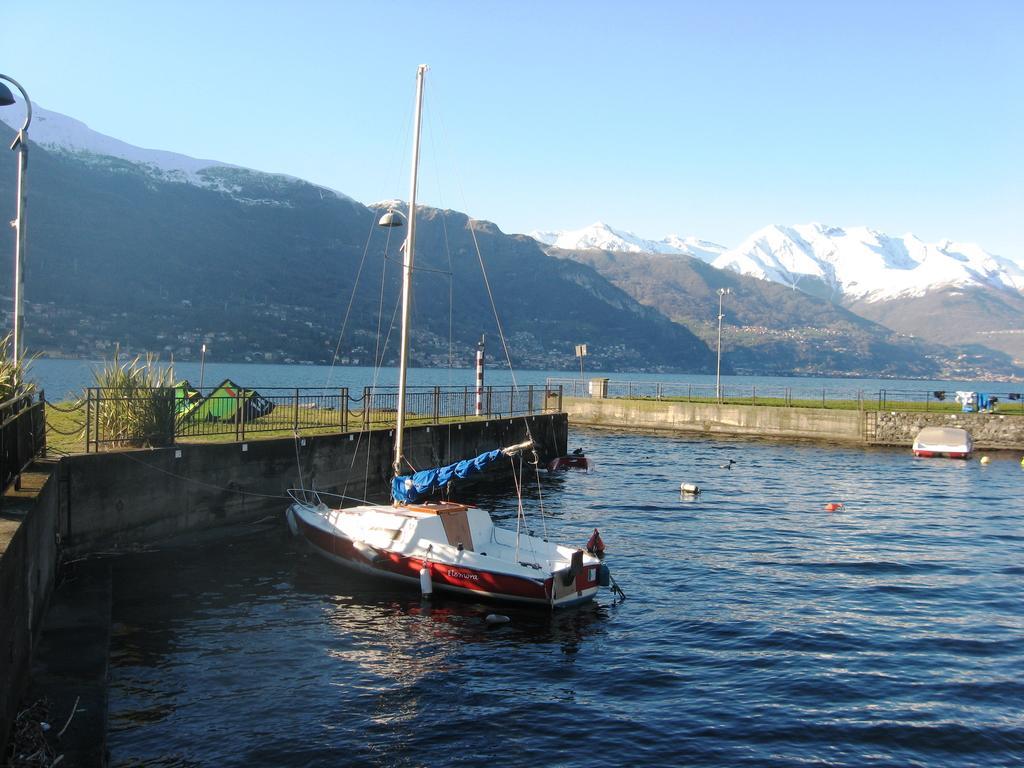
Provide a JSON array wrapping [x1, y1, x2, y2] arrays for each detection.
[[81, 385, 562, 453]]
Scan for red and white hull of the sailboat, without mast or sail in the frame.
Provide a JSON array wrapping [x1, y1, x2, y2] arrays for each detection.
[[287, 502, 600, 607]]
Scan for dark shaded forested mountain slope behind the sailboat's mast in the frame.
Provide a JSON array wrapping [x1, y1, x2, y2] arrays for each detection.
[[0, 118, 714, 372]]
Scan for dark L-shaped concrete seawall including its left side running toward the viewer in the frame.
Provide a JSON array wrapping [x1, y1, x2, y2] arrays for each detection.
[[0, 413, 568, 755]]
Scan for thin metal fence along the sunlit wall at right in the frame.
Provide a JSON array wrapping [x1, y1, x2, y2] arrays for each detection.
[[547, 379, 1024, 415]]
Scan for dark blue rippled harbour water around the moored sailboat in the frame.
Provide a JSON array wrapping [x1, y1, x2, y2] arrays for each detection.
[[109, 432, 1024, 767]]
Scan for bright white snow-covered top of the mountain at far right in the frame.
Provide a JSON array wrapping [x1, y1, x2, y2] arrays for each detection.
[[712, 223, 1024, 302]]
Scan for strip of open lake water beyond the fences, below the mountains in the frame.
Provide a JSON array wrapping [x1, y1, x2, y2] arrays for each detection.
[[29, 359, 1021, 402]]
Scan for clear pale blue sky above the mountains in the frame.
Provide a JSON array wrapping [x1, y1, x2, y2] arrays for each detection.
[[0, 0, 1024, 261]]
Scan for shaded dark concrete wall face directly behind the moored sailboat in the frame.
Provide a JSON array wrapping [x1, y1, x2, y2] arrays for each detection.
[[59, 414, 567, 555]]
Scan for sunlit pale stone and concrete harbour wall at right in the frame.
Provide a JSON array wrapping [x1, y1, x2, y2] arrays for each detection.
[[563, 397, 1024, 451]]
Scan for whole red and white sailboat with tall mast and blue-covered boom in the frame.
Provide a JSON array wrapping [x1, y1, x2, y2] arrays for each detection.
[[286, 66, 611, 608]]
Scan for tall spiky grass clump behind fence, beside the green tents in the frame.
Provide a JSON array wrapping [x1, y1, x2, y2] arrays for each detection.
[[92, 349, 174, 446]]
